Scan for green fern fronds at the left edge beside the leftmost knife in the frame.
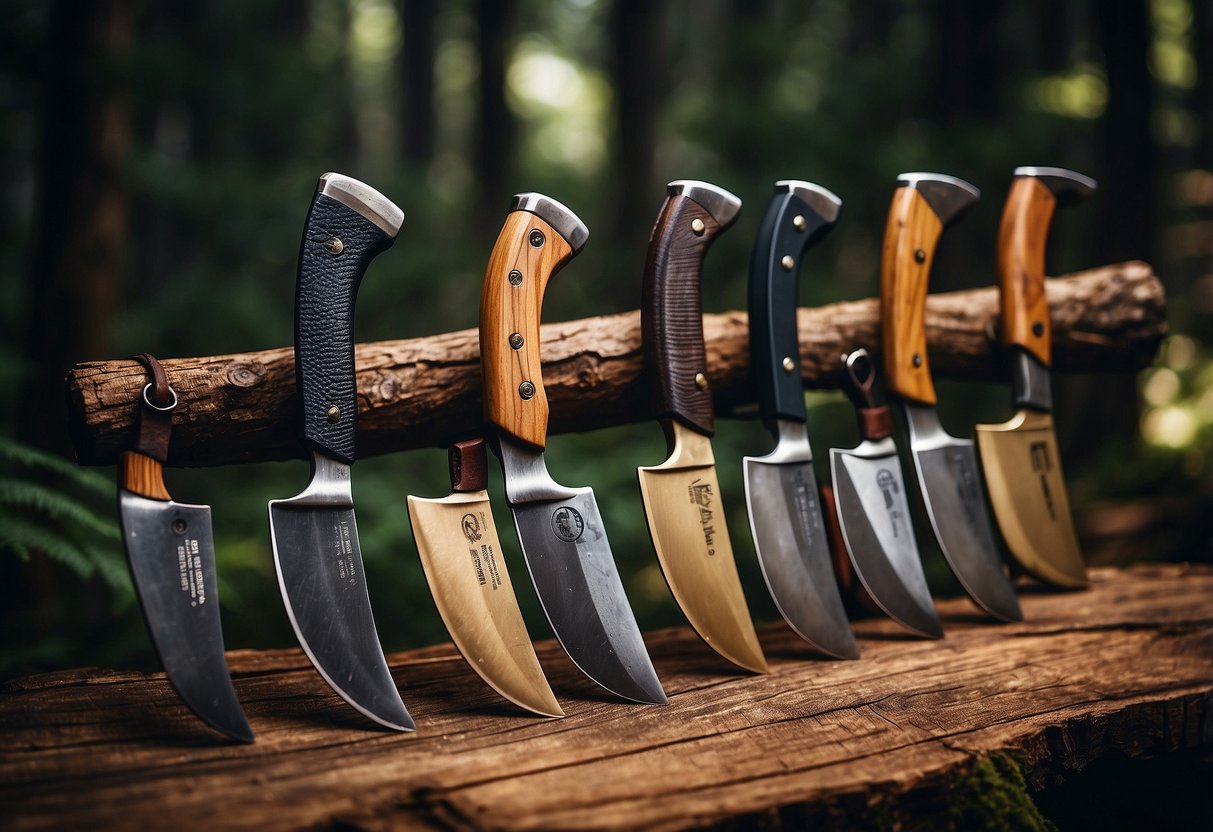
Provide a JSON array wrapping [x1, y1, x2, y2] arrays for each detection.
[[0, 437, 135, 606]]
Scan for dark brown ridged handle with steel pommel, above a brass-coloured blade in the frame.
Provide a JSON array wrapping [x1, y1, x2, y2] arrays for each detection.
[[640, 179, 741, 435]]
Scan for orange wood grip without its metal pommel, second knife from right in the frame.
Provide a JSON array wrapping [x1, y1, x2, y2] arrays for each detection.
[[881, 188, 944, 405]]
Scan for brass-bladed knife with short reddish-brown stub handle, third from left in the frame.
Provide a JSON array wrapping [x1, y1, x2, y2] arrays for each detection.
[[409, 439, 564, 717]]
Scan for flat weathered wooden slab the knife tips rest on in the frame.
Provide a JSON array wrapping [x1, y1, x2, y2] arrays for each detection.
[[0, 565, 1213, 831]]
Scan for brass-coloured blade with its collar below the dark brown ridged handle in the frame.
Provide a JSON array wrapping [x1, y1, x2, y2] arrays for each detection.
[[637, 422, 767, 673]]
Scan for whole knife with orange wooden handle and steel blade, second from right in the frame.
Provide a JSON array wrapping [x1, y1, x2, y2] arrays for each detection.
[[881, 173, 1024, 621]]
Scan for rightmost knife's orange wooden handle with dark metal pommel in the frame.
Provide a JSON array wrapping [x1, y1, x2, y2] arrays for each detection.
[[998, 167, 1097, 366]]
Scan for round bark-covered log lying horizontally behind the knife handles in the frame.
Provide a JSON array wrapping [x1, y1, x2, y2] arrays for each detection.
[[67, 262, 1167, 466]]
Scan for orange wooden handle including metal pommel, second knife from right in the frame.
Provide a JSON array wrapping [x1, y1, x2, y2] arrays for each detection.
[[881, 173, 980, 405]]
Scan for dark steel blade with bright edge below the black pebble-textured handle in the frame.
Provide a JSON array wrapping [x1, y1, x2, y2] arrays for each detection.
[[269, 470, 415, 731]]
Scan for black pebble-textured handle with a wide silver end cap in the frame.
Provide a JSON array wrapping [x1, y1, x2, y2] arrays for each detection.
[[295, 173, 404, 465]]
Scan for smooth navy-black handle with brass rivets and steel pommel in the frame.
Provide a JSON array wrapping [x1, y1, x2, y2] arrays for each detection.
[[750, 179, 842, 422]]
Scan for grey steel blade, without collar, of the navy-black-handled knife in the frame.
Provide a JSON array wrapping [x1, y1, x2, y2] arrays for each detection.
[[744, 450, 859, 659]]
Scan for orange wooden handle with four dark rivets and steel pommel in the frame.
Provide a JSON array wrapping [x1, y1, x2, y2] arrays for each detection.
[[480, 193, 590, 449]]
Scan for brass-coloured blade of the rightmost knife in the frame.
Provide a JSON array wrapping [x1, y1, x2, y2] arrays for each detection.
[[975, 409, 1087, 589]]
